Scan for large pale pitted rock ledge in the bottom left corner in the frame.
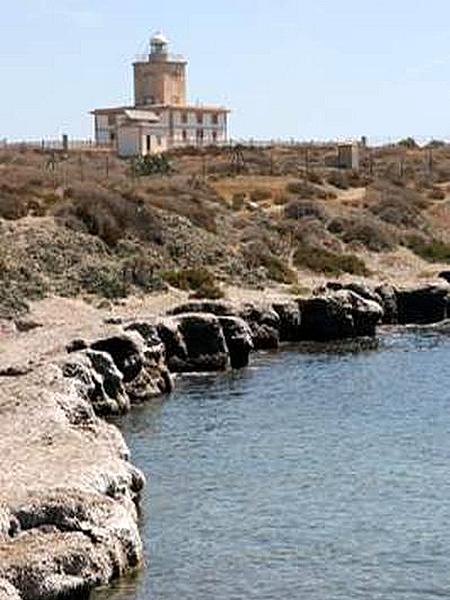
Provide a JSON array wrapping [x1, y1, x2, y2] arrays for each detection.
[[0, 491, 142, 599]]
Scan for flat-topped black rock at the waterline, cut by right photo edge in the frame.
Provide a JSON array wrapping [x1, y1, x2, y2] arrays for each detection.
[[396, 285, 449, 325]]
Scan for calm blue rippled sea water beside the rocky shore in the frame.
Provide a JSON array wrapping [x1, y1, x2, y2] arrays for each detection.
[[94, 332, 450, 600]]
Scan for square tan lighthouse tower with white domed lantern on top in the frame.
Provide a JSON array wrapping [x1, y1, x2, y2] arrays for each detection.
[[133, 33, 187, 107]]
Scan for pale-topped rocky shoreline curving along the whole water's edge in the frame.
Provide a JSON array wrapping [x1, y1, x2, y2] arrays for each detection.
[[0, 282, 450, 600]]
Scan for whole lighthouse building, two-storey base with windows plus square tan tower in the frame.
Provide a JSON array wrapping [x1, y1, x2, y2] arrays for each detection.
[[92, 33, 229, 156]]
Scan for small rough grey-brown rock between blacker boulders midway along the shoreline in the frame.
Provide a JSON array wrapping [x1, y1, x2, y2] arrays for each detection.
[[238, 303, 280, 350]]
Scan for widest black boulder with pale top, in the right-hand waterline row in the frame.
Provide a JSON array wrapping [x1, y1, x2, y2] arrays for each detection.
[[299, 290, 383, 341]]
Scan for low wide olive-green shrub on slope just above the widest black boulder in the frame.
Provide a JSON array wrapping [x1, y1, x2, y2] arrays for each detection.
[[294, 246, 369, 276]]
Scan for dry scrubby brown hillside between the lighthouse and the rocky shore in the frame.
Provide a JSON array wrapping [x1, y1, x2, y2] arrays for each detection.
[[0, 143, 450, 318]]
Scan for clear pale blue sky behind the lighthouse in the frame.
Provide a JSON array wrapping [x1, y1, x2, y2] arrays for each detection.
[[0, 0, 450, 139]]
